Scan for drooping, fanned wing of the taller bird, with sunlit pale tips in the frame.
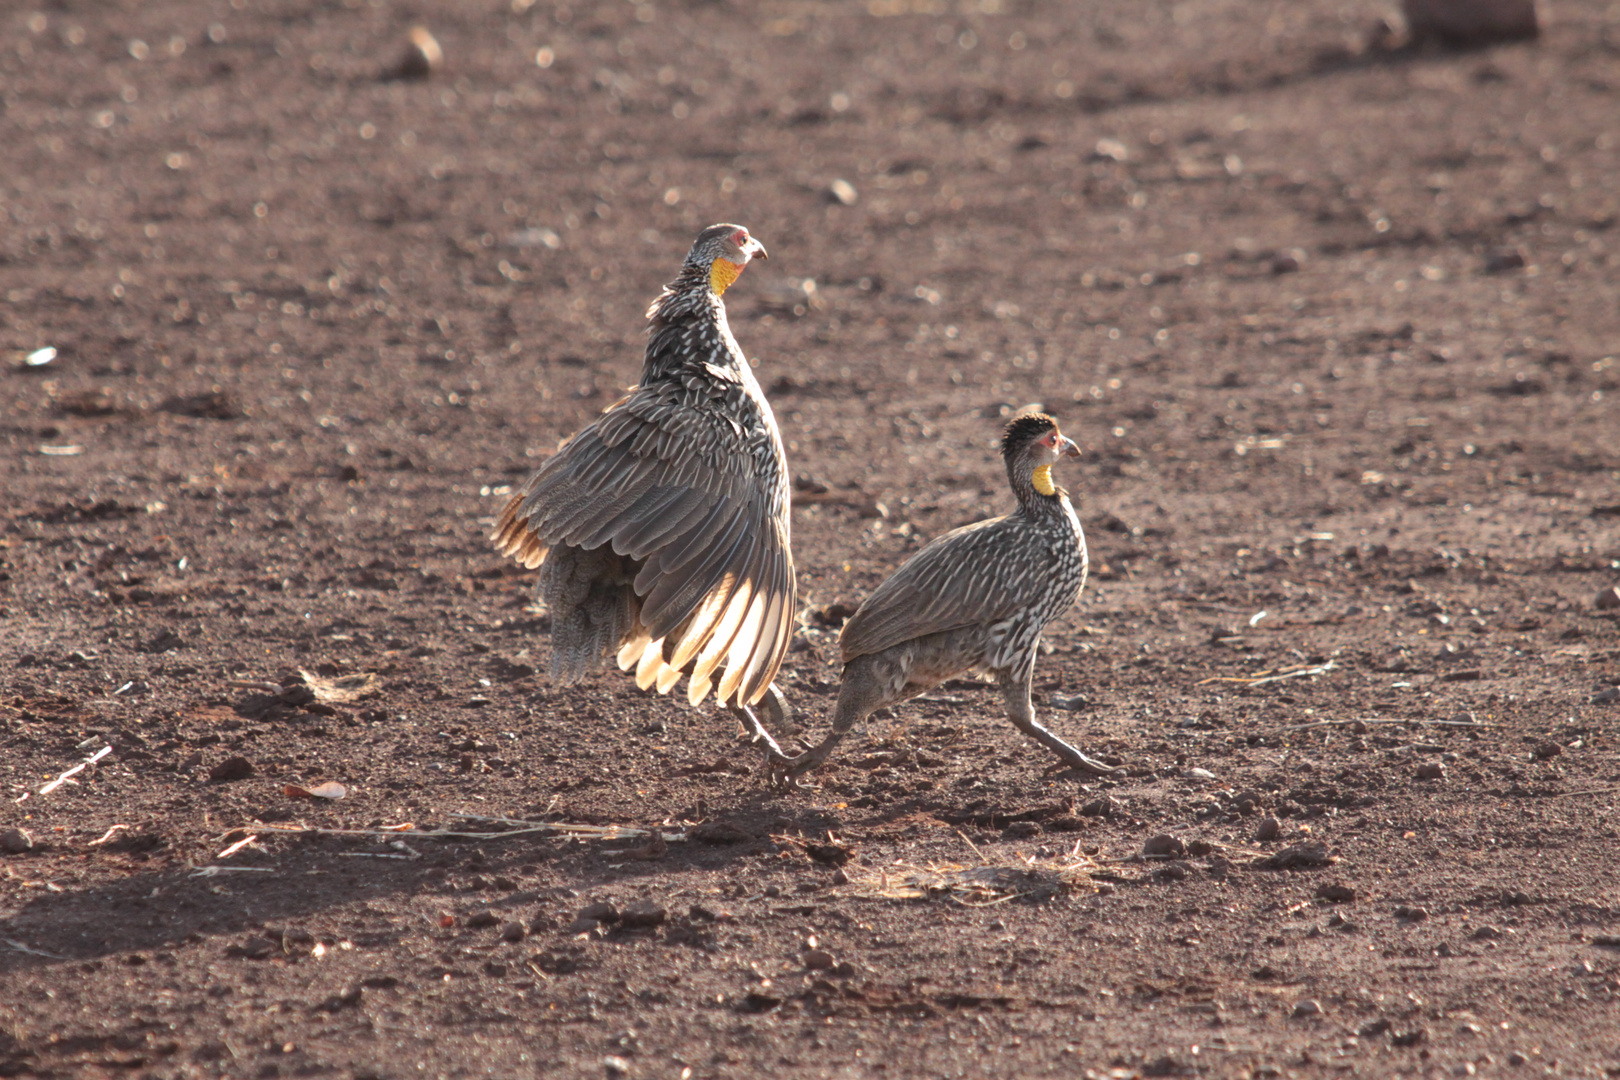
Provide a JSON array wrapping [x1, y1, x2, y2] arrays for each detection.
[[492, 385, 795, 703]]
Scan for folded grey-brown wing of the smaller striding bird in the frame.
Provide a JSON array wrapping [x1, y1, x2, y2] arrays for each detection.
[[839, 518, 1051, 662]]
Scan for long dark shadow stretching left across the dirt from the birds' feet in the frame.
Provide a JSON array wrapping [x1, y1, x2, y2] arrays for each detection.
[[0, 792, 874, 975]]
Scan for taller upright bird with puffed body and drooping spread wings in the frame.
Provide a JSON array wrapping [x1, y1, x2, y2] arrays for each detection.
[[492, 225, 795, 733]]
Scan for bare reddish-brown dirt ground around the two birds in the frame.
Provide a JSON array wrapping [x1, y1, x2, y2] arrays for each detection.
[[0, 0, 1620, 1077]]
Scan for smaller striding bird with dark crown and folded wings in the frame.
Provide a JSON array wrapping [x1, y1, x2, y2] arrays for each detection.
[[770, 413, 1118, 780]]
